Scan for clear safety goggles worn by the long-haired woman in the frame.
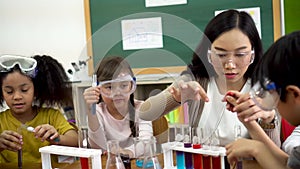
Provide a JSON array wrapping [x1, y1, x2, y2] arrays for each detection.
[[207, 50, 254, 67]]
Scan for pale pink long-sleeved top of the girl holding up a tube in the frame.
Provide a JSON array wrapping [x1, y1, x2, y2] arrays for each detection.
[[88, 100, 153, 154]]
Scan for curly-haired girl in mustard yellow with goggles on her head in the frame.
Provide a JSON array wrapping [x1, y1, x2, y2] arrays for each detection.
[[0, 55, 78, 163]]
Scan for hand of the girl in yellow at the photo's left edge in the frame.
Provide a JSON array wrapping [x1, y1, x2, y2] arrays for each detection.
[[0, 130, 23, 151]]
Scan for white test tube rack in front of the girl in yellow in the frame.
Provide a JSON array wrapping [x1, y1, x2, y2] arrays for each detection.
[[39, 145, 102, 169]]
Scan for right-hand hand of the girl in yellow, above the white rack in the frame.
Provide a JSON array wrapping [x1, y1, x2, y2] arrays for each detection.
[[34, 124, 60, 144]]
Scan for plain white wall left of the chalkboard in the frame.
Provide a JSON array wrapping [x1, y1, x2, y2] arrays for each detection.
[[0, 0, 86, 69]]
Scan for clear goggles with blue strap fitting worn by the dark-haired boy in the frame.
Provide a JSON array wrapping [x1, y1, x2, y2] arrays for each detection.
[[250, 80, 281, 111]]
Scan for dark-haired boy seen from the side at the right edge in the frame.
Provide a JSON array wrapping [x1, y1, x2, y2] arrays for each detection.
[[226, 31, 300, 169]]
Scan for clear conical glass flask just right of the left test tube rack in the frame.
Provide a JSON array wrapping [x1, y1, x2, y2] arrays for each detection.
[[105, 140, 125, 169]]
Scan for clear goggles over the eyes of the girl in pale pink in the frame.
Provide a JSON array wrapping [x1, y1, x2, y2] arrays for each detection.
[[99, 75, 136, 98]]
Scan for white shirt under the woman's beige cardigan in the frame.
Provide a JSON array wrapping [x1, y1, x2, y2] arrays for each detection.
[[198, 78, 251, 146]]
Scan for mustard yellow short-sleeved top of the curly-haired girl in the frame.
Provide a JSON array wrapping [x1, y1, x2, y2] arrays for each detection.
[[0, 108, 74, 163]]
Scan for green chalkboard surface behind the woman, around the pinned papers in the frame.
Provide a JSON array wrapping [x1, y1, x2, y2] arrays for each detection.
[[90, 0, 274, 68]]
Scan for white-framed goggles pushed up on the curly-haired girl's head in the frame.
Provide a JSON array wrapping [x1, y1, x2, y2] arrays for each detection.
[[0, 55, 37, 75]]
